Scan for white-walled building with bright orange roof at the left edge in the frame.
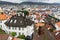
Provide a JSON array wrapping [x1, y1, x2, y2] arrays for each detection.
[[0, 13, 11, 31]]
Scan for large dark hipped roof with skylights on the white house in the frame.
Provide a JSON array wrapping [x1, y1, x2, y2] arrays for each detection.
[[5, 15, 33, 27]]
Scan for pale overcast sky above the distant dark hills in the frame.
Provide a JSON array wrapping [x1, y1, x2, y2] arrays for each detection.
[[0, 0, 60, 3]]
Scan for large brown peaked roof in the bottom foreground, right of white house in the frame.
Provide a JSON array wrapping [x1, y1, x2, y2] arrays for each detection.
[[33, 27, 56, 40]]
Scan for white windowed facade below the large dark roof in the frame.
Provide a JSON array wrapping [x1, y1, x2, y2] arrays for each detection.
[[7, 25, 34, 37]]
